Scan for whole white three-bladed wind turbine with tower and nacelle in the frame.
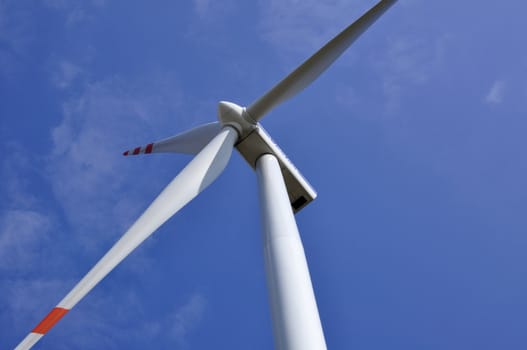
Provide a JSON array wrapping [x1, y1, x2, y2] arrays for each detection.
[[16, 0, 396, 350]]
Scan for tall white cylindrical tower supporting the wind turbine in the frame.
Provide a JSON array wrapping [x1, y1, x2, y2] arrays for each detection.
[[256, 154, 326, 350]]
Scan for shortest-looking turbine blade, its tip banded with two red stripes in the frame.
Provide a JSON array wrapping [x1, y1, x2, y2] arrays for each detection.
[[123, 122, 221, 156]]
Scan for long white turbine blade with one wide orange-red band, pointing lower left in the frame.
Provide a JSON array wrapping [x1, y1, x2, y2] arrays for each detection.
[[16, 127, 238, 350]]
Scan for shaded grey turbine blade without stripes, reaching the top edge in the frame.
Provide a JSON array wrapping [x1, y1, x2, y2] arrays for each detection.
[[246, 0, 397, 122]]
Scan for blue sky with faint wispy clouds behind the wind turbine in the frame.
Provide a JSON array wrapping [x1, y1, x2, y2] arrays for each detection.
[[0, 0, 527, 349]]
